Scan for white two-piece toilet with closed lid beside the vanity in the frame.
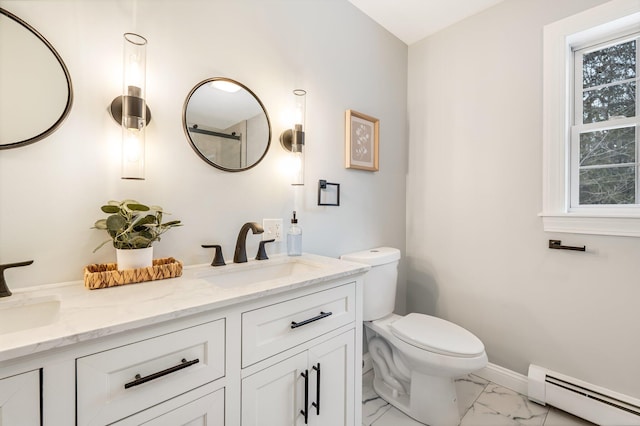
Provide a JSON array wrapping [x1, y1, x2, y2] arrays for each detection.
[[341, 247, 487, 426]]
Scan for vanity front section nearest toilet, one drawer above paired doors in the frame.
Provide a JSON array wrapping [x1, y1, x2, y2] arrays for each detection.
[[241, 283, 356, 426]]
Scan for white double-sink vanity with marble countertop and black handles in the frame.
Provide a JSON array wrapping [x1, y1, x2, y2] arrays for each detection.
[[0, 254, 368, 426]]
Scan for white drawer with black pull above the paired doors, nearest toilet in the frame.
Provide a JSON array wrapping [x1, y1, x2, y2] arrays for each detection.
[[242, 283, 355, 368]]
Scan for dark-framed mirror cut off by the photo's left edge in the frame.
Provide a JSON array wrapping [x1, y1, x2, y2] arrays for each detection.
[[0, 8, 73, 149]]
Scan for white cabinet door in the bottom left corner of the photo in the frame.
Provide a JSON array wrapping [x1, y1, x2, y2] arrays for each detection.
[[0, 370, 40, 426]]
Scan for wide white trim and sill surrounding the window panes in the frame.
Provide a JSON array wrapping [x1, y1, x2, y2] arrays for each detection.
[[540, 0, 640, 237]]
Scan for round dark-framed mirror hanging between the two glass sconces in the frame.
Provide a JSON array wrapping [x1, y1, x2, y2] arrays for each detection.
[[182, 77, 271, 172]]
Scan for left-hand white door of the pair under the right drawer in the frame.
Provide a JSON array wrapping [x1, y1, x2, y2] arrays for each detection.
[[242, 352, 307, 426]]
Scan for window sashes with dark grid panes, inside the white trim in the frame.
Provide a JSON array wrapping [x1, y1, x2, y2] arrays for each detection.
[[570, 35, 640, 211]]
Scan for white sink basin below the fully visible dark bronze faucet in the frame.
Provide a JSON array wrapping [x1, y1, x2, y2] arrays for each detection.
[[198, 258, 323, 288]]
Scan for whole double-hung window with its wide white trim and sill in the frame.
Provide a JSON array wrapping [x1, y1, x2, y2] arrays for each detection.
[[541, 0, 640, 236]]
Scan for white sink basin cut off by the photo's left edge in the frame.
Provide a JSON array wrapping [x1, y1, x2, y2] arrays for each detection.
[[0, 294, 60, 334]]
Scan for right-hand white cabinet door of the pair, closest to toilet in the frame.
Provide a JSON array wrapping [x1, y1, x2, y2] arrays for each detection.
[[309, 330, 355, 426]]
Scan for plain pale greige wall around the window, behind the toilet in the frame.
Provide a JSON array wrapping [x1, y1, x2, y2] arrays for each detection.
[[407, 0, 640, 397]]
